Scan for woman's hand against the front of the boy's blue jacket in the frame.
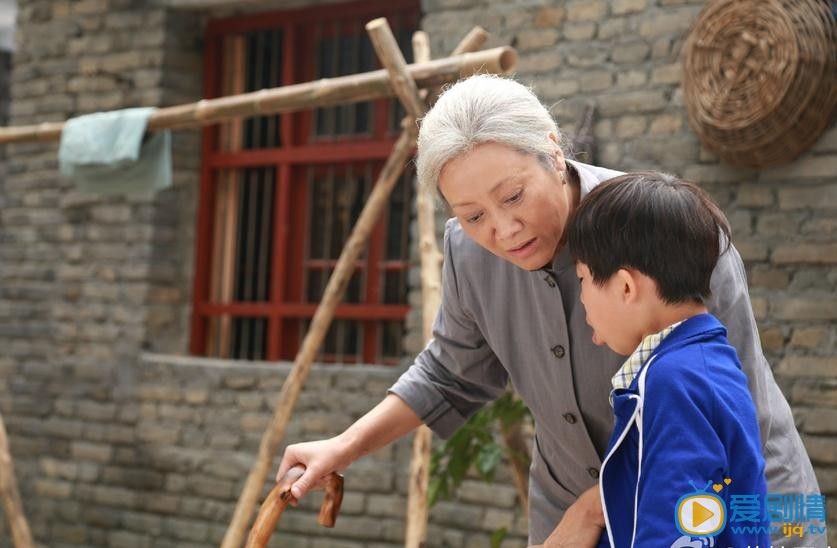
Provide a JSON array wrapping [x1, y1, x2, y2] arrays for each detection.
[[542, 485, 605, 548]]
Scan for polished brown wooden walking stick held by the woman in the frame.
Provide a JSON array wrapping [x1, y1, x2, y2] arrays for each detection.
[[245, 466, 343, 548]]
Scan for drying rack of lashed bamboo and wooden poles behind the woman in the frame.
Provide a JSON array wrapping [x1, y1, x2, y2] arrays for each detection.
[[0, 19, 517, 548]]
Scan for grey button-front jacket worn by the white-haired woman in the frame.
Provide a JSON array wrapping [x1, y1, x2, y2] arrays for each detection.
[[390, 162, 826, 546]]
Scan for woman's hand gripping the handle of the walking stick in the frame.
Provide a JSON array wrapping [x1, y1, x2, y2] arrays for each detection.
[[276, 436, 351, 500]]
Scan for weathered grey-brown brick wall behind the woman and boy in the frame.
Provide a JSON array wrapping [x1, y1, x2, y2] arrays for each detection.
[[0, 0, 837, 548]]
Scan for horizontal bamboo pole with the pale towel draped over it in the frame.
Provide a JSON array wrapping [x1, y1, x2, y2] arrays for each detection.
[[0, 47, 517, 143]]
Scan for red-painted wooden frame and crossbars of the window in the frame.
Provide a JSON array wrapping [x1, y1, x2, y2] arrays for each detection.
[[190, 0, 419, 363]]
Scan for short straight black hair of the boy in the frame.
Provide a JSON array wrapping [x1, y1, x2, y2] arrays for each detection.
[[566, 171, 730, 304]]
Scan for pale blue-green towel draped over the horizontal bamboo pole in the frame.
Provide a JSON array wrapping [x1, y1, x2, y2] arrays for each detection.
[[58, 108, 172, 195]]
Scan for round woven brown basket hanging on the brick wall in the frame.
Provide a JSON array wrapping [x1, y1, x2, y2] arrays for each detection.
[[683, 0, 837, 168]]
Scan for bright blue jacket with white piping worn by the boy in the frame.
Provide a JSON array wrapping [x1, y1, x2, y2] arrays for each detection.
[[599, 314, 770, 548]]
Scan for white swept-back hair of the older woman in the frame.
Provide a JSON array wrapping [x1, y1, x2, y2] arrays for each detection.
[[416, 74, 561, 193]]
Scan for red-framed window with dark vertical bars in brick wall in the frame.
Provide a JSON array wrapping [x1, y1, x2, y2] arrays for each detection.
[[191, 0, 419, 364]]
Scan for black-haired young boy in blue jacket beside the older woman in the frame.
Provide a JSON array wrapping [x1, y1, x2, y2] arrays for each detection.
[[567, 173, 770, 548]]
